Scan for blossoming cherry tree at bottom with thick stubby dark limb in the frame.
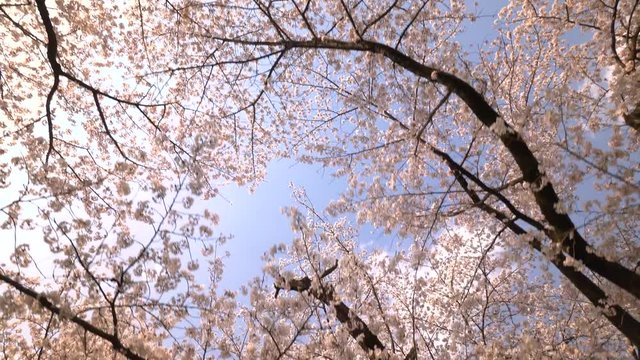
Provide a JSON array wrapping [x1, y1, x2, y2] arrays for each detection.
[[234, 195, 626, 359]]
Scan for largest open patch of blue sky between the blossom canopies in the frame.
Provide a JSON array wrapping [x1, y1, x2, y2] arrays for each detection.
[[212, 159, 346, 288]]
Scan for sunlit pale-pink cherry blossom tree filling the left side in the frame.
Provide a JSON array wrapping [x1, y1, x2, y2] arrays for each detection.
[[0, 0, 240, 359]]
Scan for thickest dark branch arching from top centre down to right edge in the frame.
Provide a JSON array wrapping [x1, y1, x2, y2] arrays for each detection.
[[211, 38, 640, 299]]
